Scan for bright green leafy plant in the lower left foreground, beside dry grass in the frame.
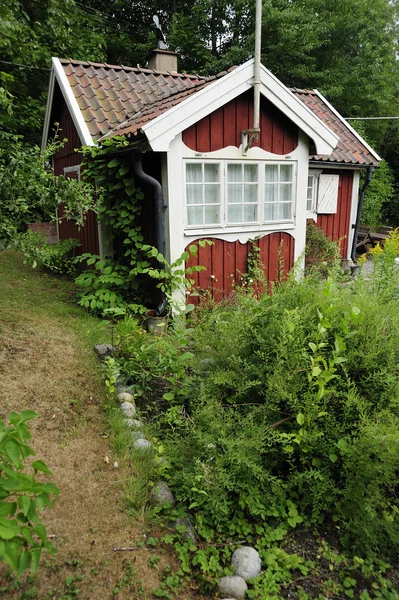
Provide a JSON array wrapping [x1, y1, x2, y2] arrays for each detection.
[[0, 410, 59, 575]]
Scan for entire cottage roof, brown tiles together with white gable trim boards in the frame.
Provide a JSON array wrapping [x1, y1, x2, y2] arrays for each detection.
[[43, 58, 380, 166]]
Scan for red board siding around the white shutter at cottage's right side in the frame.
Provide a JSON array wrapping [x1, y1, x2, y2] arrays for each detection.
[[317, 170, 353, 258]]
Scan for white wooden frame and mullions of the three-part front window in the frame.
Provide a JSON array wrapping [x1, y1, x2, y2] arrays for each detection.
[[183, 157, 298, 231]]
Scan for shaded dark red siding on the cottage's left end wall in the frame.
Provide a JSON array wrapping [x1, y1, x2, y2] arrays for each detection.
[[54, 103, 100, 255]]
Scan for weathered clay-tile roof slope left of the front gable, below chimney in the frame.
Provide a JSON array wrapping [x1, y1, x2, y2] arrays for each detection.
[[60, 59, 209, 139]]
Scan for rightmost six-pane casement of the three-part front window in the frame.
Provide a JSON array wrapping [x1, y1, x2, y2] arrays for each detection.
[[264, 164, 293, 222]]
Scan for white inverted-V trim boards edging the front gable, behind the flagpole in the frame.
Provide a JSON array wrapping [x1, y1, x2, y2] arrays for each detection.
[[143, 59, 339, 155]]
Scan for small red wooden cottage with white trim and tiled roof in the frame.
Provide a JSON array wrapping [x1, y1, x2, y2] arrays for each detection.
[[43, 50, 380, 297]]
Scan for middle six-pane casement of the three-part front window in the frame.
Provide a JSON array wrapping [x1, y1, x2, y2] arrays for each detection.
[[227, 163, 259, 223]]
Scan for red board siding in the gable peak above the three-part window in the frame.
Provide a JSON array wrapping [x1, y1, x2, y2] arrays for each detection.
[[183, 90, 298, 154]]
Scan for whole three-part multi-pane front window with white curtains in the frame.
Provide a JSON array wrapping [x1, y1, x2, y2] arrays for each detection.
[[185, 160, 295, 227]]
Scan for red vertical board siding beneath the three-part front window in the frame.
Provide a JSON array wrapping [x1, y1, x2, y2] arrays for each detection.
[[186, 232, 295, 304]]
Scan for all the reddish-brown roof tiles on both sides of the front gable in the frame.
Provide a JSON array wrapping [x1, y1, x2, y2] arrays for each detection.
[[60, 59, 378, 166]]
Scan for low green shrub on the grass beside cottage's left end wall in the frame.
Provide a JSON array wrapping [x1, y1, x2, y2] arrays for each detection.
[[14, 231, 80, 275]]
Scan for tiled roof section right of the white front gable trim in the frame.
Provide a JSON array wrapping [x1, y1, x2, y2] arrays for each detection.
[[291, 88, 379, 166]]
